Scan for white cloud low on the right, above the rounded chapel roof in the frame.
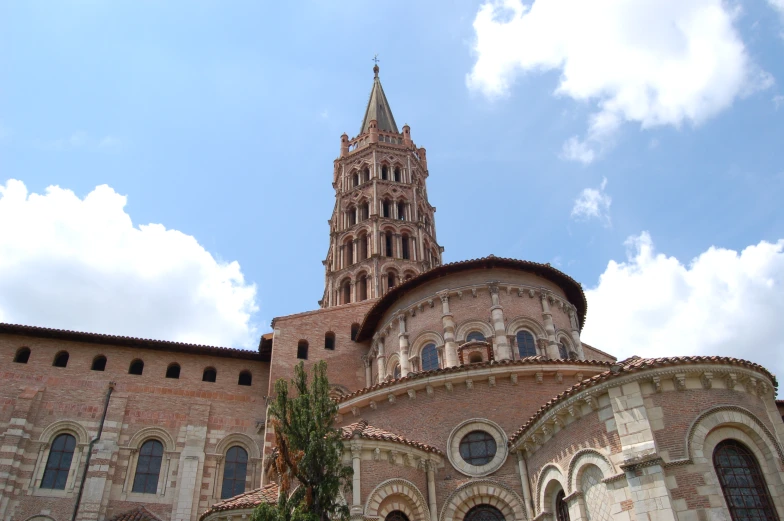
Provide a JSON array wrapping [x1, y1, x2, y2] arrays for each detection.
[[583, 232, 784, 390]]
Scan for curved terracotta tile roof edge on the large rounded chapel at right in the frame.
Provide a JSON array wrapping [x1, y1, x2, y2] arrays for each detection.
[[509, 356, 778, 447]]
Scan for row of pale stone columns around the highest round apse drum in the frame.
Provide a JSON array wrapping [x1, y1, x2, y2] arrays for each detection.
[[367, 283, 585, 385]]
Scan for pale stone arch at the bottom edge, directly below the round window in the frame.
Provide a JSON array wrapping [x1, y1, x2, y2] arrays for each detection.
[[439, 479, 526, 521]]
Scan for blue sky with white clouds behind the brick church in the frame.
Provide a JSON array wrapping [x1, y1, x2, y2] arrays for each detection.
[[0, 0, 784, 382]]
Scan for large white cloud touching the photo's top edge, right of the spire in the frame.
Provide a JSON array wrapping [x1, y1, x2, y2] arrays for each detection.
[[466, 0, 784, 162]]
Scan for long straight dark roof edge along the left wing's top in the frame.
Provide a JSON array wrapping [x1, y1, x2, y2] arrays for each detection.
[[0, 322, 261, 360]]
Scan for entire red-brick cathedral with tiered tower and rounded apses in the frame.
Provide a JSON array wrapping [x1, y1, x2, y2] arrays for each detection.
[[0, 66, 784, 521]]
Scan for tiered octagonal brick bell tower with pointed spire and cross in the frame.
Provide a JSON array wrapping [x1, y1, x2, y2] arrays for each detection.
[[319, 64, 444, 308]]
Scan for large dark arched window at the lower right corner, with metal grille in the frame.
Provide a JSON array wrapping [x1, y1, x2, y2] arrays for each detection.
[[713, 440, 779, 521]]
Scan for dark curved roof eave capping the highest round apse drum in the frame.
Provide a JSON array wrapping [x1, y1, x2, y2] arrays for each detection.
[[357, 255, 588, 342]]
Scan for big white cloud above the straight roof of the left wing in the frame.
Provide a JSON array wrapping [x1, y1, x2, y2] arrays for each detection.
[[0, 179, 257, 347]]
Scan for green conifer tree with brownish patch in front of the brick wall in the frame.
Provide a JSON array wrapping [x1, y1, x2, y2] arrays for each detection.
[[252, 362, 353, 521]]
